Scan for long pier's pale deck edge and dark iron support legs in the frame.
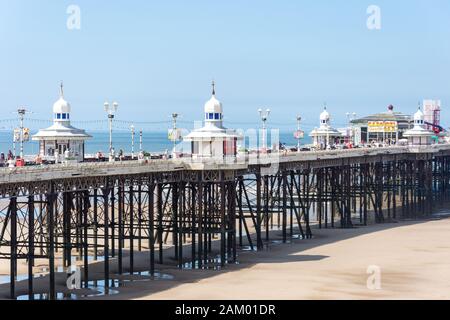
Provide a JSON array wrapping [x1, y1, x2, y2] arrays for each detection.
[[0, 144, 450, 299]]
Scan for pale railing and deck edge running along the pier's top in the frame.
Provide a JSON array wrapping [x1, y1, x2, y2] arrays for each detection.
[[0, 144, 450, 184]]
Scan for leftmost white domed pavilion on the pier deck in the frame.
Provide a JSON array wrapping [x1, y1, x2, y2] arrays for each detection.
[[33, 83, 92, 161]]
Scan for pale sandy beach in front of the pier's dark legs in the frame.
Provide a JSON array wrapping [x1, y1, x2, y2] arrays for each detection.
[[0, 218, 450, 300]]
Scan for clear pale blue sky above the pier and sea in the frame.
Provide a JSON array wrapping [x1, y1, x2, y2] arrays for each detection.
[[0, 0, 450, 127]]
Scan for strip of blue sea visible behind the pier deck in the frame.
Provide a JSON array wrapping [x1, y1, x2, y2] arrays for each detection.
[[0, 130, 311, 156]]
